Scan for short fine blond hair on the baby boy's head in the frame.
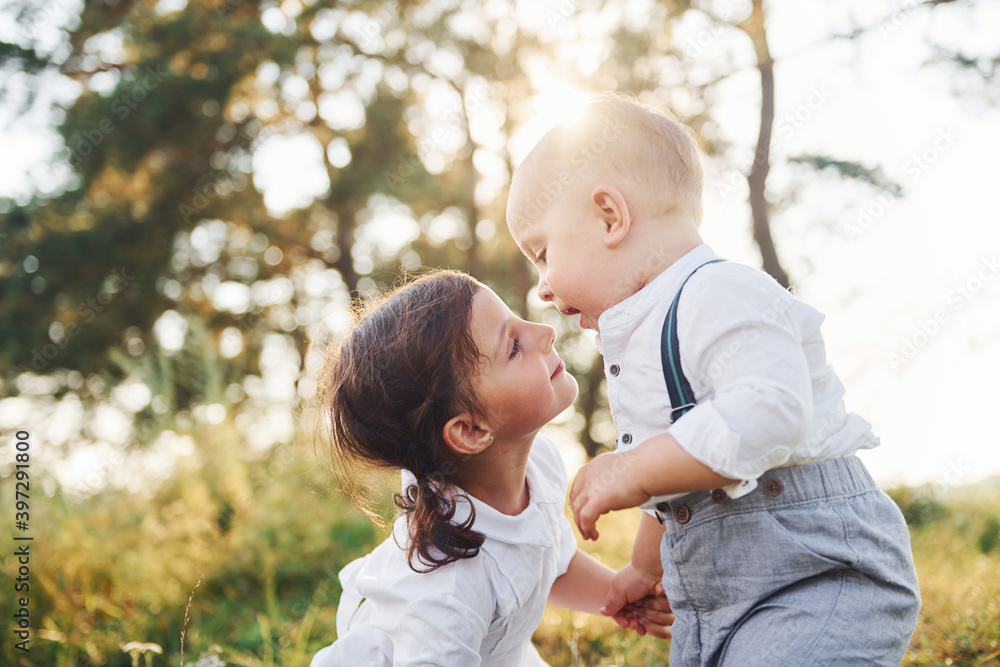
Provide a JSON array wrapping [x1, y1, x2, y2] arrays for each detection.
[[510, 93, 704, 224]]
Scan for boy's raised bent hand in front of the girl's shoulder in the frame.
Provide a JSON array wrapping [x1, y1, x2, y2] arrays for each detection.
[[569, 452, 650, 540]]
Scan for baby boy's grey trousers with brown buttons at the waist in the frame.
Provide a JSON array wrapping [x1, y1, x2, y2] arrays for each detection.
[[660, 456, 920, 667]]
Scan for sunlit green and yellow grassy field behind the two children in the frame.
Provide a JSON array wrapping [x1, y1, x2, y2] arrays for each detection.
[[0, 444, 1000, 667]]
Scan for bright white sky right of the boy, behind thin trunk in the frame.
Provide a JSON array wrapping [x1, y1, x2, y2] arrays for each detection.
[[703, 1, 1000, 488]]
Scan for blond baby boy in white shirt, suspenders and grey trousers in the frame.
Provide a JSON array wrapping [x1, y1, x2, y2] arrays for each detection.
[[507, 95, 920, 667]]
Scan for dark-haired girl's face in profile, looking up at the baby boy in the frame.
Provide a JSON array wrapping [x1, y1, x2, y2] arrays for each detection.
[[471, 287, 577, 440]]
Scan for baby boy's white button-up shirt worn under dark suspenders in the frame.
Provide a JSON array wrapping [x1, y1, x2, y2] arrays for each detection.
[[597, 244, 879, 511]]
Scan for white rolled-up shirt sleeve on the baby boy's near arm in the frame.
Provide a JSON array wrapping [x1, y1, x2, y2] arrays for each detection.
[[670, 269, 813, 488]]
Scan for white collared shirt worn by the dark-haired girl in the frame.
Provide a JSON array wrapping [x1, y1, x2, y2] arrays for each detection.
[[311, 436, 577, 667]]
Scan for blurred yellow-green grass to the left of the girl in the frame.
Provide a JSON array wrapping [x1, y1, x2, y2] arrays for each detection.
[[0, 438, 383, 667]]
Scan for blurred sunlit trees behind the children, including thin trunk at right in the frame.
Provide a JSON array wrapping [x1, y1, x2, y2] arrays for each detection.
[[0, 0, 960, 474]]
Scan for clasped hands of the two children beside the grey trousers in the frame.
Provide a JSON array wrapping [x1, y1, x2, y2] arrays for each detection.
[[601, 564, 675, 639]]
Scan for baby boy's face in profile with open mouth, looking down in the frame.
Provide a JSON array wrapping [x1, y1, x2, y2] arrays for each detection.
[[508, 198, 627, 331]]
